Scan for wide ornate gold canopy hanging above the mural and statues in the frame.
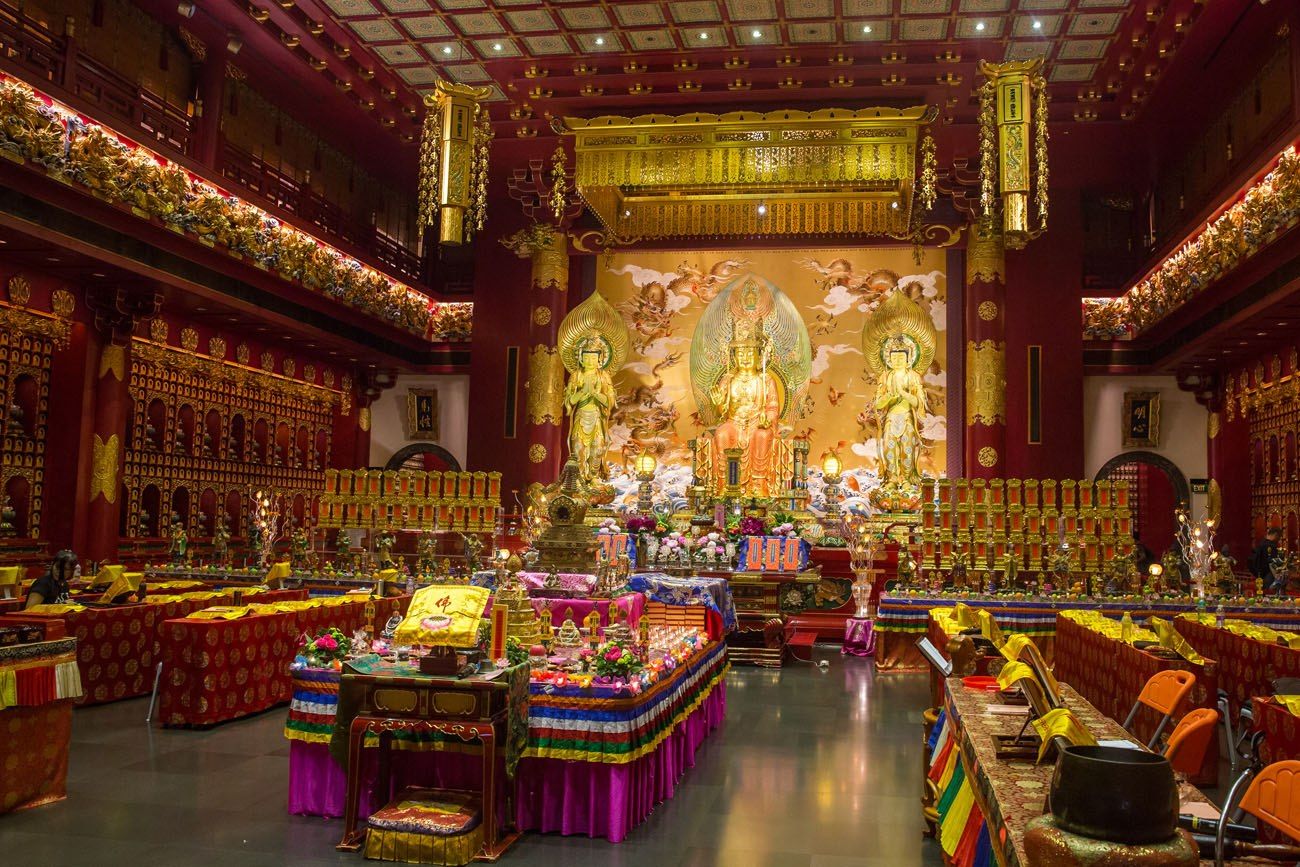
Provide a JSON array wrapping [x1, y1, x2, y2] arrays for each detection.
[[554, 105, 935, 238]]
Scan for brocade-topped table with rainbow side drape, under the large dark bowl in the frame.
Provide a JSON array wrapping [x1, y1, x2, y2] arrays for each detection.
[[928, 679, 1237, 867]]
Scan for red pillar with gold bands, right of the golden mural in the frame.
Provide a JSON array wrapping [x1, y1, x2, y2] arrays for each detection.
[[965, 213, 1006, 478]]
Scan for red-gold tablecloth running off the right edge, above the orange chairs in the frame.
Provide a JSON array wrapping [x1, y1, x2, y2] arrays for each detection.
[[1174, 615, 1300, 715]]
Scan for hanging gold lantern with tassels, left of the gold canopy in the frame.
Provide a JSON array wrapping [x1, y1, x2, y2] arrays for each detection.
[[419, 81, 491, 246]]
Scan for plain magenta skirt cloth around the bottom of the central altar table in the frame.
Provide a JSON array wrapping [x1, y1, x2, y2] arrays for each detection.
[[289, 681, 727, 842]]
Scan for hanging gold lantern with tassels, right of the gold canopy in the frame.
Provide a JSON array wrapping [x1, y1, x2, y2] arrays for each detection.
[[979, 57, 1047, 248]]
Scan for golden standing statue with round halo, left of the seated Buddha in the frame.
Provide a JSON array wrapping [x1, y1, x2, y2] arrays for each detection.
[[559, 292, 628, 487]]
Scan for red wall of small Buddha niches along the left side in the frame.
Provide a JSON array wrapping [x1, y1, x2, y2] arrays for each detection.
[[0, 265, 365, 563]]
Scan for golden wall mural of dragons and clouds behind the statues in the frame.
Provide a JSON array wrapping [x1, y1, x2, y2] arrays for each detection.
[[597, 247, 948, 512]]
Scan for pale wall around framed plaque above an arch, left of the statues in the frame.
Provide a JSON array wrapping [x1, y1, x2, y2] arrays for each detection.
[[371, 374, 470, 471]]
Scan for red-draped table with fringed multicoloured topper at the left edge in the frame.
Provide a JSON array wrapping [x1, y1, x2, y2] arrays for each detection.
[[0, 638, 82, 814]]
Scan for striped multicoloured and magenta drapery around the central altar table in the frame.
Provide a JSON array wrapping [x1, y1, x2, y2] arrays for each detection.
[[285, 642, 728, 842]]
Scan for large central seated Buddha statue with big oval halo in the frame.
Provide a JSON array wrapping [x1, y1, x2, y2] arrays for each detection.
[[690, 277, 811, 498]]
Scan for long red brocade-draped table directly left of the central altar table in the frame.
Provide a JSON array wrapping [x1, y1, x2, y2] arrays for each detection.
[[159, 597, 411, 727]]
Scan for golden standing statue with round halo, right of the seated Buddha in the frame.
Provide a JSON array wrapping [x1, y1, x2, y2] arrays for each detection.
[[862, 291, 939, 508]]
